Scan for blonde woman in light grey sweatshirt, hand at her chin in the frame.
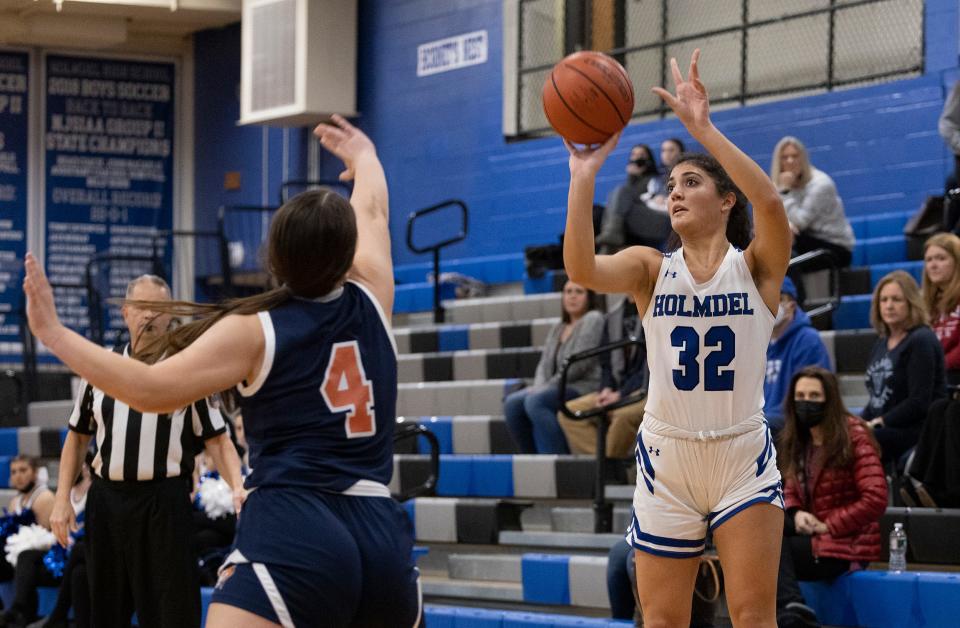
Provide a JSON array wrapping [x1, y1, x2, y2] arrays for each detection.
[[770, 135, 856, 270]]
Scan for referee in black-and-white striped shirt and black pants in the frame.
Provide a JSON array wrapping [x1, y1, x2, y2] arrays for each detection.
[[51, 275, 243, 628]]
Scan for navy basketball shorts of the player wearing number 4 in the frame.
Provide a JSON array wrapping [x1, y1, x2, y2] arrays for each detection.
[[213, 488, 421, 628]]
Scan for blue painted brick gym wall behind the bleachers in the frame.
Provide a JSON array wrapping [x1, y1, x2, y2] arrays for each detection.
[[196, 0, 958, 263]]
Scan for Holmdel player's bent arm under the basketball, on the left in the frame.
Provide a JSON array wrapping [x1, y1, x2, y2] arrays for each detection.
[[563, 133, 661, 303]]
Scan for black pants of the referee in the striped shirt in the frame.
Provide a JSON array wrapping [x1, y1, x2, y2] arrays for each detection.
[[86, 478, 200, 628]]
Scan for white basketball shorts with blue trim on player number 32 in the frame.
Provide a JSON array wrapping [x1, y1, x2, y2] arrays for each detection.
[[626, 416, 783, 558]]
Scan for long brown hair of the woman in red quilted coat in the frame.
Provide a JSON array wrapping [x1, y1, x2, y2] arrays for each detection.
[[777, 366, 879, 479]]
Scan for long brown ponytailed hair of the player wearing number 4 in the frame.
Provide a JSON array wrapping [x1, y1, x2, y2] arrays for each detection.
[[128, 188, 357, 363]]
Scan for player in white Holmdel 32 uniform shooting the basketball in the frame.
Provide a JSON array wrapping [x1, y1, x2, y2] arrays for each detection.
[[563, 50, 791, 627]]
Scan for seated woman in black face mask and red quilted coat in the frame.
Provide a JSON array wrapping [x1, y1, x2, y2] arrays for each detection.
[[777, 366, 887, 628]]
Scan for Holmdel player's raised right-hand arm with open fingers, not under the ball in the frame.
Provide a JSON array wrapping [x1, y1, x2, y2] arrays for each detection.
[[653, 49, 793, 310]]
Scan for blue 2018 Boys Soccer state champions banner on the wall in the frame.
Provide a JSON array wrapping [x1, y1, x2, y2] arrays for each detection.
[[44, 55, 176, 345]]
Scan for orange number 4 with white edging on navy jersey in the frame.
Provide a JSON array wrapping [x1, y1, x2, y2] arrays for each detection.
[[320, 340, 377, 438]]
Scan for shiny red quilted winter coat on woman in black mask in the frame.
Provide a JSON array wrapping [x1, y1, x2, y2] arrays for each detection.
[[784, 417, 887, 562]]
